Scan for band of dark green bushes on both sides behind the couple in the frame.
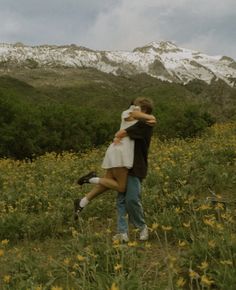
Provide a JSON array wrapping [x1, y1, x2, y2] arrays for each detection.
[[0, 95, 214, 159]]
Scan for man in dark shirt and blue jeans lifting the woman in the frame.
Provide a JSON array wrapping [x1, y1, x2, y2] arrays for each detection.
[[113, 99, 153, 242]]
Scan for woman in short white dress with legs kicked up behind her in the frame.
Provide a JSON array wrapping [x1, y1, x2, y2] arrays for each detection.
[[74, 98, 156, 218]]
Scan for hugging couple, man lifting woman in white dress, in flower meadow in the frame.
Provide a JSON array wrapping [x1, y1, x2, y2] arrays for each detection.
[[74, 97, 156, 242]]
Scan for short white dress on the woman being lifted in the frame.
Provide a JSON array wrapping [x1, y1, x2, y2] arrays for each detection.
[[102, 105, 137, 169]]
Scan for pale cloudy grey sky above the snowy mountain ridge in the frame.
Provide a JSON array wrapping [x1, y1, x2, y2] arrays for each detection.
[[0, 0, 236, 59]]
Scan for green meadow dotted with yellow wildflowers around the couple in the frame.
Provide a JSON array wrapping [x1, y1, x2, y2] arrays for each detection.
[[0, 123, 236, 290]]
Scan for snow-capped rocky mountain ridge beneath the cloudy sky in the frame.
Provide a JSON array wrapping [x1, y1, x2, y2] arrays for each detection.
[[0, 41, 236, 87]]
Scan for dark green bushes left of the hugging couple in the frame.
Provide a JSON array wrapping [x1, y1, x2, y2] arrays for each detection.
[[0, 96, 119, 159]]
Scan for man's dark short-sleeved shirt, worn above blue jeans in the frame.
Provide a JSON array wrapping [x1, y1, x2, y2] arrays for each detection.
[[125, 121, 153, 179]]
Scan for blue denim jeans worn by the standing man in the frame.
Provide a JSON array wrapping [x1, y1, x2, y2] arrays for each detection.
[[117, 175, 146, 233]]
